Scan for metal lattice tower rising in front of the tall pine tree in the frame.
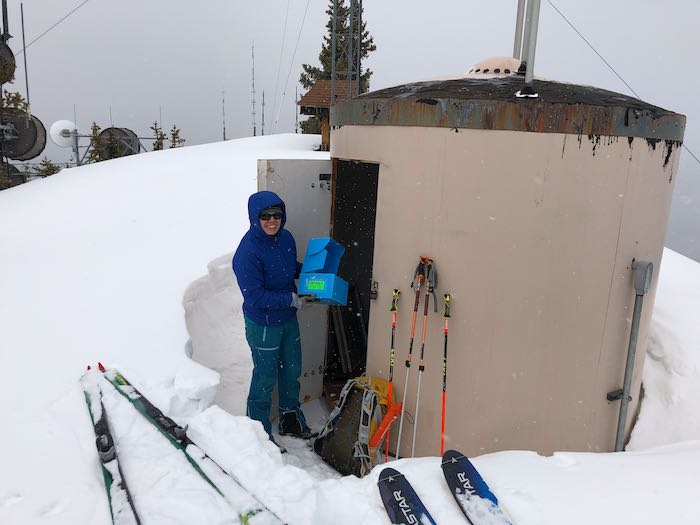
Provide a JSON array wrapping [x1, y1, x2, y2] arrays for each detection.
[[331, 0, 362, 108]]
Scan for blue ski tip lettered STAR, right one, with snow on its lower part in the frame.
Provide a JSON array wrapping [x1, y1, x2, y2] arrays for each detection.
[[441, 450, 511, 525]]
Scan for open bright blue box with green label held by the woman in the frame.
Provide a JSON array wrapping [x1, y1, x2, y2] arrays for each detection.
[[299, 237, 348, 306]]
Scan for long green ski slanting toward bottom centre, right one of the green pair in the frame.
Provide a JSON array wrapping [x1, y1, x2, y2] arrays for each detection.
[[99, 363, 282, 525]]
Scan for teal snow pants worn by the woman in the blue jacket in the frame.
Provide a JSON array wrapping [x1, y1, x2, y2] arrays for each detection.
[[245, 315, 305, 435]]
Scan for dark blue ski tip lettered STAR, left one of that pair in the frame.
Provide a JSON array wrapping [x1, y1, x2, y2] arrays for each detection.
[[377, 468, 436, 525]]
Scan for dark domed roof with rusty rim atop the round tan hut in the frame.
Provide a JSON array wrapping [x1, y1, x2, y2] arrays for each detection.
[[330, 75, 685, 141]]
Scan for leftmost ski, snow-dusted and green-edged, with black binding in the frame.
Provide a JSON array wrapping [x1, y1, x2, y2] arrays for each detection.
[[80, 368, 141, 525]]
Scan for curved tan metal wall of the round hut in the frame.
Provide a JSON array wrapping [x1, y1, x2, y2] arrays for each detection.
[[331, 125, 679, 455]]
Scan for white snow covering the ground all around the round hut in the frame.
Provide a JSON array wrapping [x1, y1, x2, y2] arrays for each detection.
[[0, 135, 700, 525]]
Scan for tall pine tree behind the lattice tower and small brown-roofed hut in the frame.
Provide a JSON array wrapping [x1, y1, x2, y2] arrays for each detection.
[[299, 0, 377, 133]]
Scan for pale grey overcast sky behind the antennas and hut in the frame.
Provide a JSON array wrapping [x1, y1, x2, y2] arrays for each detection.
[[6, 0, 700, 260]]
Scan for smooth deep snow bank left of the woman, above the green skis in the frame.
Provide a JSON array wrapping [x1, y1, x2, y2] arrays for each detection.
[[0, 135, 328, 525]]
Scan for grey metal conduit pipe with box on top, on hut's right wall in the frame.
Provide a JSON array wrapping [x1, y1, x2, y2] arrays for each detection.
[[615, 261, 654, 452]]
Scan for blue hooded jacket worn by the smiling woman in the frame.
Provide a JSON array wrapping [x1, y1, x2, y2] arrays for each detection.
[[232, 191, 301, 326]]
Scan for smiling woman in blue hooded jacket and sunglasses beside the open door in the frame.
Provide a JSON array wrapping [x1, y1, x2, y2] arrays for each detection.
[[233, 191, 313, 441]]
